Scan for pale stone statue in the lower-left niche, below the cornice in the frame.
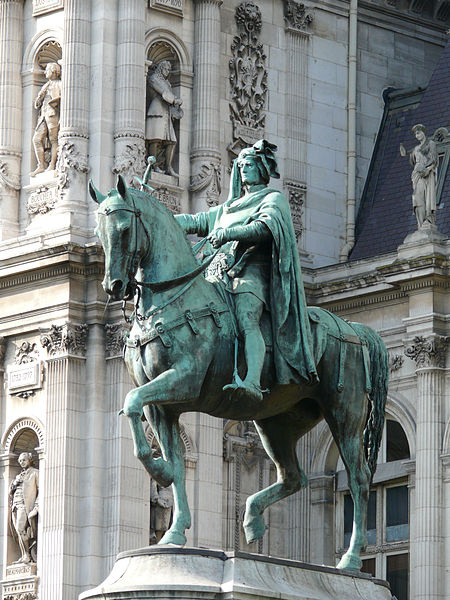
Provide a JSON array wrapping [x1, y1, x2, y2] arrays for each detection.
[[9, 452, 39, 563]]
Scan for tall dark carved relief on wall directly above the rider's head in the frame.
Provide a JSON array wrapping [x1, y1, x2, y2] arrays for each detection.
[[229, 0, 267, 154]]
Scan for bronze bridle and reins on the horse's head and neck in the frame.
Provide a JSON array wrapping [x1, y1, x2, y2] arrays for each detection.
[[101, 194, 220, 323]]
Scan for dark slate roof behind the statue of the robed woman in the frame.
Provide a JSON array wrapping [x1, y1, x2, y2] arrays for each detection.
[[349, 40, 450, 260]]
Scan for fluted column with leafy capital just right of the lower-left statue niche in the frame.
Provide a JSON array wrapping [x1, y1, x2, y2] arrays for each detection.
[[38, 323, 89, 600]]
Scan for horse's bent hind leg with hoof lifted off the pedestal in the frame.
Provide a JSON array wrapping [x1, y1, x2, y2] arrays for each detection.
[[244, 413, 317, 543]]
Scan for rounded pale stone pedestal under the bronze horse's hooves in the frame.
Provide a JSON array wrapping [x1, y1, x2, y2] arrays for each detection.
[[79, 546, 391, 600]]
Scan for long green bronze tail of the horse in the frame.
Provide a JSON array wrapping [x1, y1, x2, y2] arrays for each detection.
[[351, 323, 389, 477]]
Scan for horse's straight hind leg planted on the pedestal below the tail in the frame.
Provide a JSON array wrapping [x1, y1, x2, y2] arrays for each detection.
[[334, 419, 371, 571]]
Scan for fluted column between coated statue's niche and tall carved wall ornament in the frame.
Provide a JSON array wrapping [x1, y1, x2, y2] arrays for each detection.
[[190, 0, 222, 212]]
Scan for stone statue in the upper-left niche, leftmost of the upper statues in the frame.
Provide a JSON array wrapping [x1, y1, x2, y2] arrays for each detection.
[[31, 62, 61, 177]]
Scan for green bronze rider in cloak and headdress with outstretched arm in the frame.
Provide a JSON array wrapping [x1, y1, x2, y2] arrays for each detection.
[[176, 140, 318, 401]]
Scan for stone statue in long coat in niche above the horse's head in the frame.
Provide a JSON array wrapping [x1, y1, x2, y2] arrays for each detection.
[[145, 60, 183, 176]]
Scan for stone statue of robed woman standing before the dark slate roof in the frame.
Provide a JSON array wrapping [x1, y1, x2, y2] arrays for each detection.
[[400, 124, 439, 229]]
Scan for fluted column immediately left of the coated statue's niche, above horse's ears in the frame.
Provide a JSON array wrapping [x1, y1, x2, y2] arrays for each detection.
[[113, 0, 146, 183]]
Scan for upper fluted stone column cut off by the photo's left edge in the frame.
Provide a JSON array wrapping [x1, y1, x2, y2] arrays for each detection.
[[0, 0, 23, 240]]
